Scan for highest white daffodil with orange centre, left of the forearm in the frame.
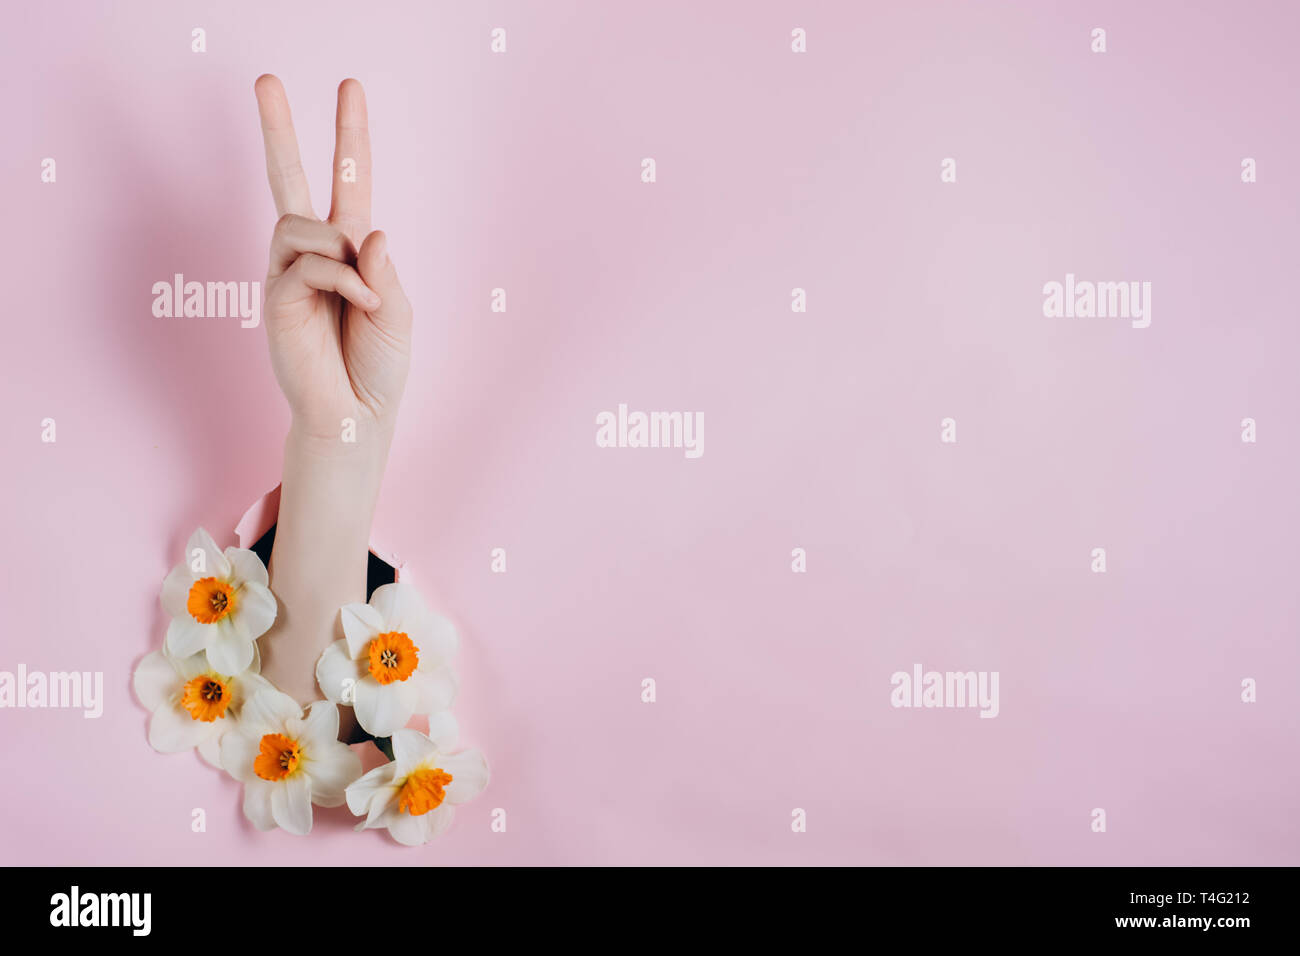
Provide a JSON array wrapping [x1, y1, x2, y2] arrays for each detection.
[[163, 528, 276, 674]]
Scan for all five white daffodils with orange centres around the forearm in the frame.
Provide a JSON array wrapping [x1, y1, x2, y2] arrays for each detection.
[[134, 528, 488, 847]]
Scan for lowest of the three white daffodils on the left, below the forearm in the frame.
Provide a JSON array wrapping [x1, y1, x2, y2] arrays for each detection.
[[221, 688, 361, 836]]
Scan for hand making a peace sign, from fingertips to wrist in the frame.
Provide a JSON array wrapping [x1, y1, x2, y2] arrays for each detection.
[[254, 74, 411, 447]]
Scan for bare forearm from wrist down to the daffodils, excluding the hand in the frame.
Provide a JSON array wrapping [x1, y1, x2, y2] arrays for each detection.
[[260, 424, 393, 704]]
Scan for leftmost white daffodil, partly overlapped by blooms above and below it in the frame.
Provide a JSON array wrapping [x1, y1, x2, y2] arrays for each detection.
[[133, 650, 270, 767]]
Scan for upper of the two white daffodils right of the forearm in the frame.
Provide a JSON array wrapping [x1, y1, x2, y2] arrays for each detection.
[[316, 583, 458, 737]]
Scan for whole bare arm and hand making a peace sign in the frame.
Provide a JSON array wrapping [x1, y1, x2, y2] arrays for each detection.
[[254, 74, 411, 739]]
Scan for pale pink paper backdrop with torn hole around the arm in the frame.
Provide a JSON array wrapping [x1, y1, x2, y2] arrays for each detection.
[[0, 0, 1300, 865]]
